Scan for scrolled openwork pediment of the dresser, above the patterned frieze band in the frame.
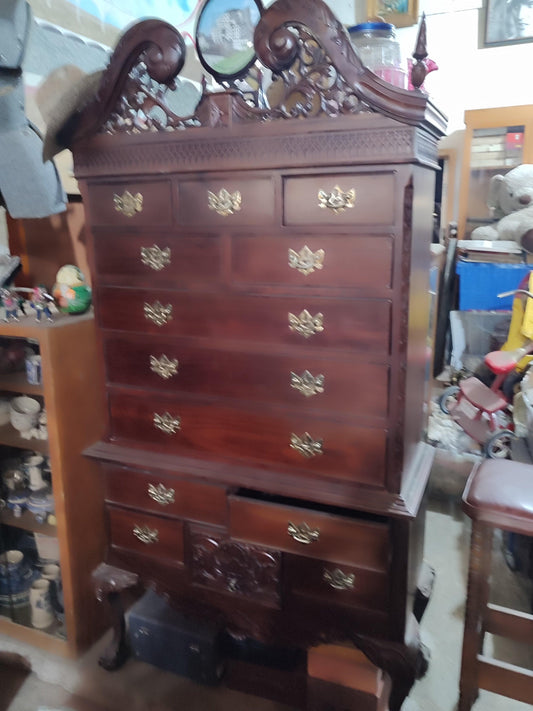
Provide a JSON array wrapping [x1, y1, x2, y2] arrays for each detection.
[[58, 0, 445, 147]]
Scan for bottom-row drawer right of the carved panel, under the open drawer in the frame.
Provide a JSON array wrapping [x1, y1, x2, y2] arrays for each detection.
[[284, 555, 389, 610]]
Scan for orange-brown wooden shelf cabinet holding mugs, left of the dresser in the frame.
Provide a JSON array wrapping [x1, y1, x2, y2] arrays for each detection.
[[0, 314, 104, 656]]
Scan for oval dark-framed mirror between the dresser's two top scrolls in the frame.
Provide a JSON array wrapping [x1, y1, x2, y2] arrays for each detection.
[[196, 0, 263, 81]]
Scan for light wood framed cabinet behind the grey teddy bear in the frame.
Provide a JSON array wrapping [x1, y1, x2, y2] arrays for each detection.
[[458, 105, 533, 239]]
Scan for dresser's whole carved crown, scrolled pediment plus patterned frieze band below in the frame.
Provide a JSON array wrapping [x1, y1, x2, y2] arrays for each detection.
[[56, 0, 446, 177]]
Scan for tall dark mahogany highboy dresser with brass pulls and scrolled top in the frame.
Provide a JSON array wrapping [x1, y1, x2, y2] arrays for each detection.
[[63, 0, 445, 708]]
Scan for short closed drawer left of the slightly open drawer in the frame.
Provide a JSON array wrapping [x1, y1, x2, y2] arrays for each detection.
[[103, 465, 227, 525]]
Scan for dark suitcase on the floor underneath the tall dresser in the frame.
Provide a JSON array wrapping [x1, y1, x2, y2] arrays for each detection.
[[128, 590, 224, 686]]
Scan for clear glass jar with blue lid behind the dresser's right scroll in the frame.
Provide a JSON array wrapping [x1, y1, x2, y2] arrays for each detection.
[[348, 22, 407, 89]]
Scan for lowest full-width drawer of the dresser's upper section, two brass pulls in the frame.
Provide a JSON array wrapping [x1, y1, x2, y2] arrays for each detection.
[[110, 392, 386, 487]]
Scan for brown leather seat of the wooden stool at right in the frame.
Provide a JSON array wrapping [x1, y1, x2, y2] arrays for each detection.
[[463, 459, 533, 536]]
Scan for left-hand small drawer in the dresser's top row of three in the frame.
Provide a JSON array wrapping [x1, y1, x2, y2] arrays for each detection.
[[89, 180, 172, 229]]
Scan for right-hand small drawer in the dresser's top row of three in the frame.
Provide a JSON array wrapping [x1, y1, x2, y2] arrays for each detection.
[[283, 171, 395, 226]]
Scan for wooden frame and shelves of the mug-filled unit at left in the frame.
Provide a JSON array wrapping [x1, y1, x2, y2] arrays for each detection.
[[0, 313, 105, 657]]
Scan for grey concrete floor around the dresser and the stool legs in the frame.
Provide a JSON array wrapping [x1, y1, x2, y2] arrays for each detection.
[[0, 451, 533, 711]]
